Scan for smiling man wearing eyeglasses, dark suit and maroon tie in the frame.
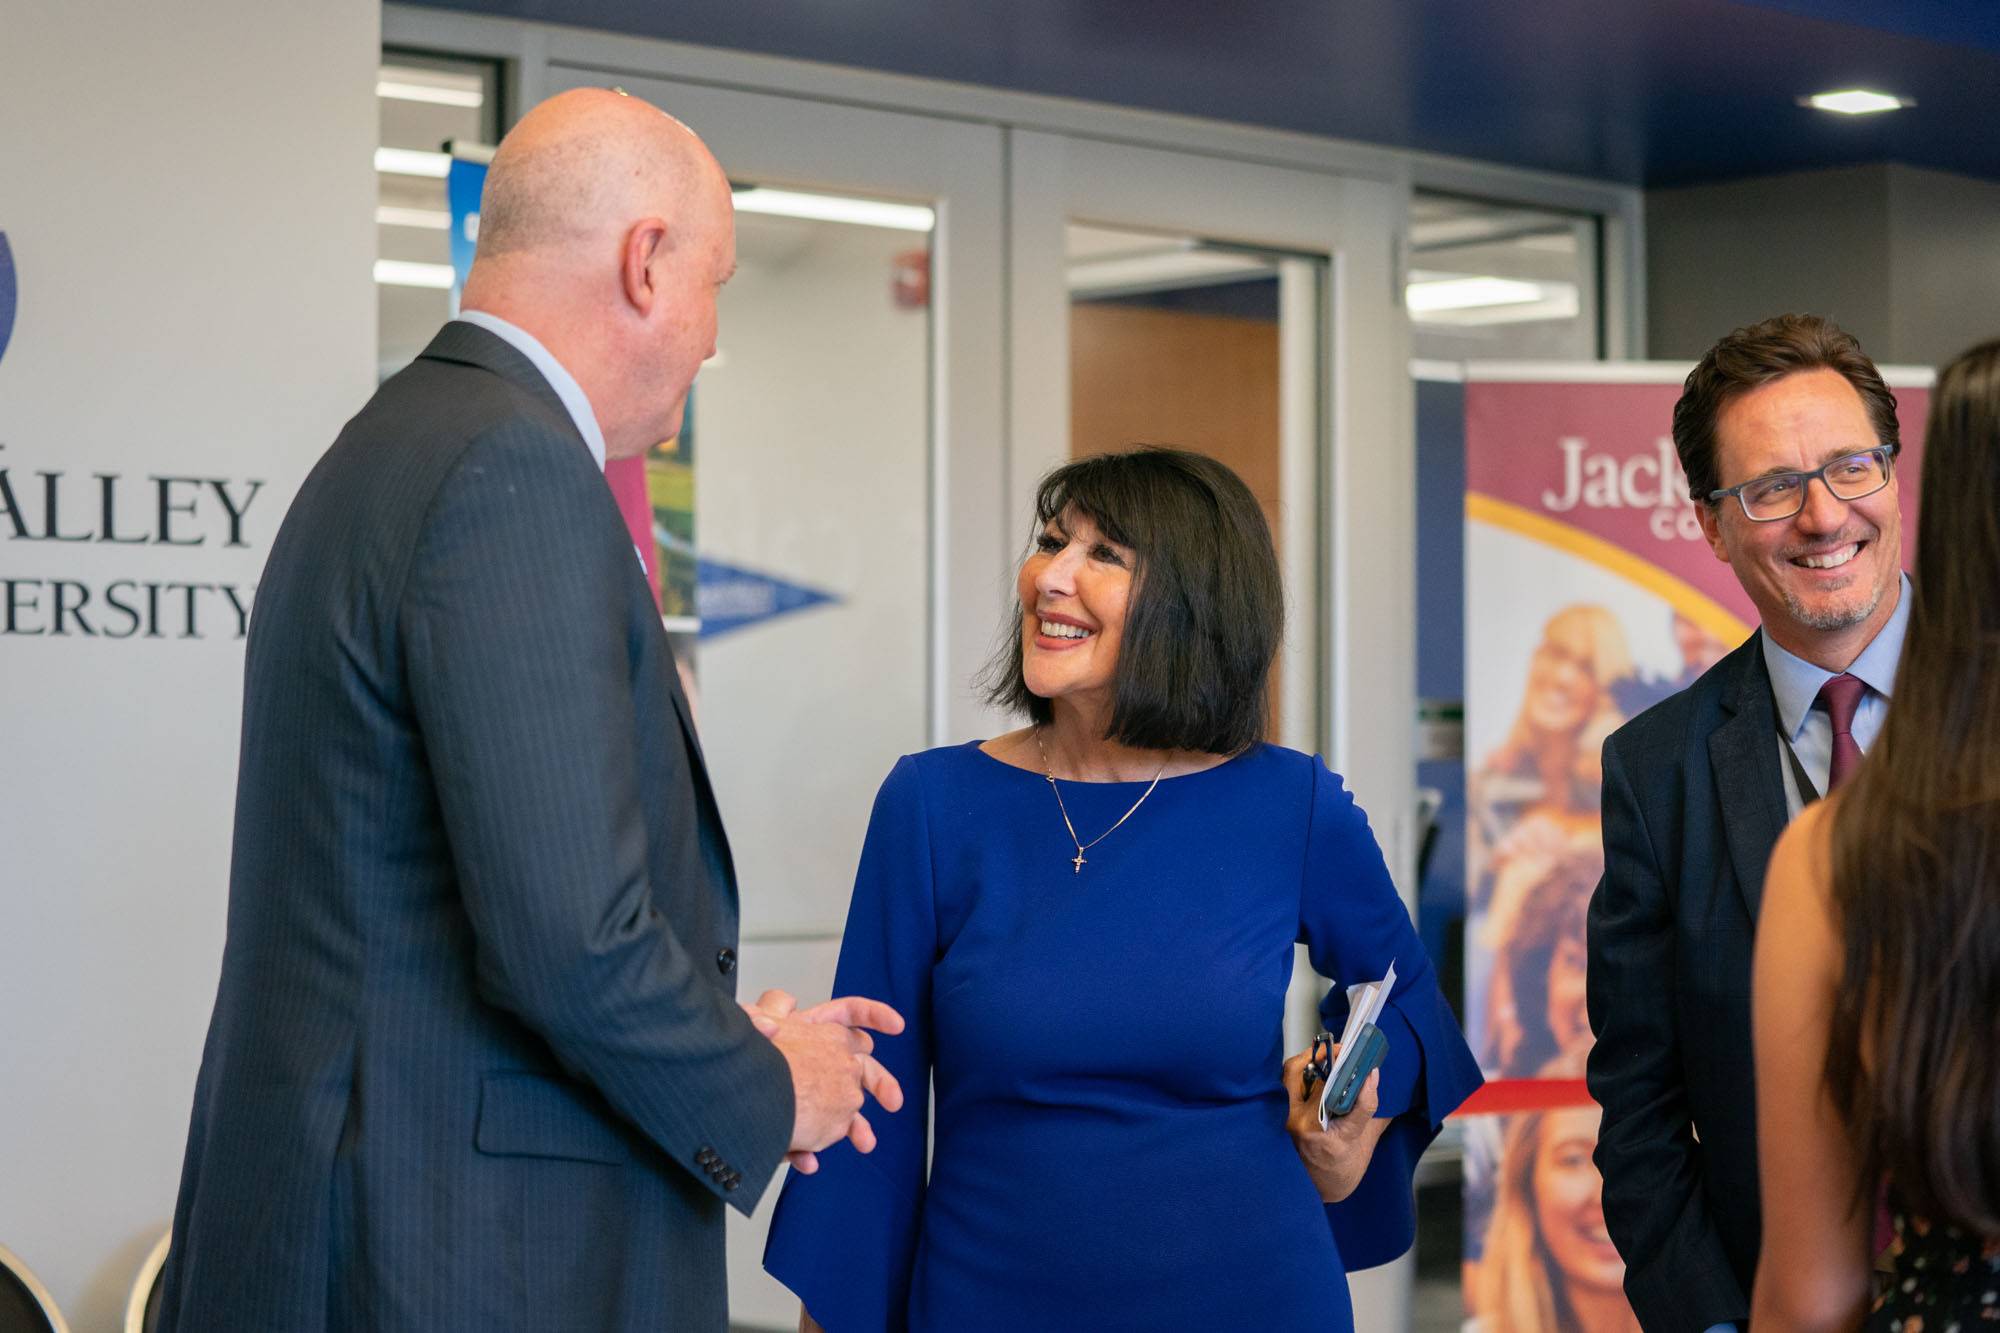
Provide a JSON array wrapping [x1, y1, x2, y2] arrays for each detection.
[[1588, 314, 1910, 1333]]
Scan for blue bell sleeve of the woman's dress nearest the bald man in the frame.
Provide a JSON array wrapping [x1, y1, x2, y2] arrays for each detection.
[[764, 755, 938, 1333]]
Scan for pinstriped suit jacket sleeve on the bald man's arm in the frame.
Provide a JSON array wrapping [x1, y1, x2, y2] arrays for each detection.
[[400, 420, 792, 1213]]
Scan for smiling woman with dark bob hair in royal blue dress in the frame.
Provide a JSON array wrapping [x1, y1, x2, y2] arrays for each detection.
[[764, 448, 1480, 1333]]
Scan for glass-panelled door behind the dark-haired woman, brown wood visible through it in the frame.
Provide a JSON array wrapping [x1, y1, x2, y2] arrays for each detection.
[[1008, 130, 1414, 1329]]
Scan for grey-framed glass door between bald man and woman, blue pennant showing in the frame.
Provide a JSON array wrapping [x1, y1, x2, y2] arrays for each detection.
[[550, 66, 1010, 1329]]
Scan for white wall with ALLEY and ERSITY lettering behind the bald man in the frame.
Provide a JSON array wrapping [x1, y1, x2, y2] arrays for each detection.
[[0, 0, 380, 1331]]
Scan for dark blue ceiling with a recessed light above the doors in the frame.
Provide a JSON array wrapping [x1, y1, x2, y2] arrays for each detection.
[[402, 0, 2000, 186]]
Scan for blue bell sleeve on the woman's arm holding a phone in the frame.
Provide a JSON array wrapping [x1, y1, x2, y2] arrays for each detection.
[[1298, 761, 1482, 1271]]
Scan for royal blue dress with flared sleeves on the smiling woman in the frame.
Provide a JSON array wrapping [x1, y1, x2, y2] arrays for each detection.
[[764, 745, 1480, 1333]]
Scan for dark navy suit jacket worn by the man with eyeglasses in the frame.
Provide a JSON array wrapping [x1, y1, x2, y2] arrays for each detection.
[[1588, 632, 1788, 1333]]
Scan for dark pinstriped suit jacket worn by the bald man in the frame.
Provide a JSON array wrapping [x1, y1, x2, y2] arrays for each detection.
[[160, 322, 792, 1333]]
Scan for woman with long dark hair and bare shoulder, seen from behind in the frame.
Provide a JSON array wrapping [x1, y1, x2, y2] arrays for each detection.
[[1752, 340, 2000, 1333]]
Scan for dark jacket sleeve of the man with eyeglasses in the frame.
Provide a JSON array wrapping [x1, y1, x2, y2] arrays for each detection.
[[1588, 737, 1750, 1333]]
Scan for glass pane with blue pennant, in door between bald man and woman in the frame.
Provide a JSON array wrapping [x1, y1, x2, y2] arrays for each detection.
[[692, 182, 932, 932]]
